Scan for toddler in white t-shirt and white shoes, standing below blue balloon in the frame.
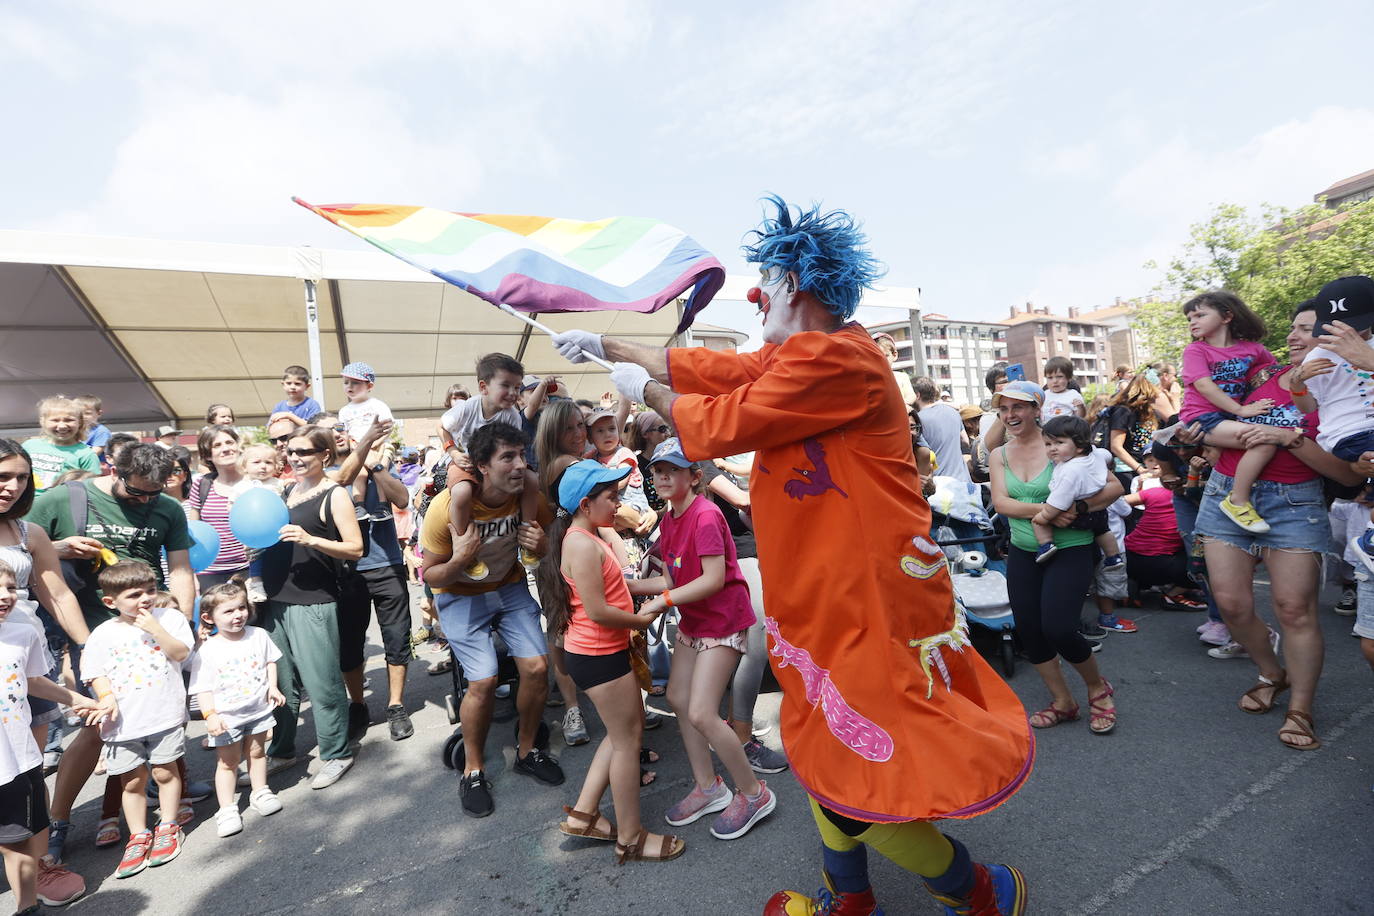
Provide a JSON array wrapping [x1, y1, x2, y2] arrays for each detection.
[[190, 581, 286, 836]]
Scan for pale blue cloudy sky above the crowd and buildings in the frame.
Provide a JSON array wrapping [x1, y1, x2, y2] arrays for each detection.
[[0, 0, 1374, 336]]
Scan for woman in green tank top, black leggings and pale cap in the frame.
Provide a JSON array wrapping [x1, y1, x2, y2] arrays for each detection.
[[988, 382, 1121, 735]]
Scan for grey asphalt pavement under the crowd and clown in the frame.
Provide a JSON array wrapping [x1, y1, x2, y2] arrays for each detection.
[[13, 582, 1374, 916]]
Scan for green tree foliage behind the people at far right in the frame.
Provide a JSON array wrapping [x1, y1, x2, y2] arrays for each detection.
[[1134, 201, 1374, 361]]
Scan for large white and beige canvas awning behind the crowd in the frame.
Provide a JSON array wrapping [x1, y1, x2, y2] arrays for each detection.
[[0, 231, 680, 430]]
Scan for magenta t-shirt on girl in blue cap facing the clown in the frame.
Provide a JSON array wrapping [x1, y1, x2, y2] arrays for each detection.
[[658, 496, 754, 637]]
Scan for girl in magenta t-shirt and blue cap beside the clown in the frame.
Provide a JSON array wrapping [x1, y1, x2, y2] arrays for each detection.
[[629, 439, 778, 839]]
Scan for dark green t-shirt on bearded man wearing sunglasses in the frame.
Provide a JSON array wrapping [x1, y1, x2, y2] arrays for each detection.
[[26, 481, 195, 630]]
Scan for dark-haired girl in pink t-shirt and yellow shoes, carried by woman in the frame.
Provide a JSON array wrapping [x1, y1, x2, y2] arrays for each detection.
[[1179, 290, 1275, 534]]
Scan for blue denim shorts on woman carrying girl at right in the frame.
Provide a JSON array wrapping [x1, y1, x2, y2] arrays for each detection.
[[1197, 471, 1331, 556]]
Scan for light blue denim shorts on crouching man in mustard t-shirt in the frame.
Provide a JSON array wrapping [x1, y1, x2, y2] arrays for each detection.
[[434, 580, 548, 681]]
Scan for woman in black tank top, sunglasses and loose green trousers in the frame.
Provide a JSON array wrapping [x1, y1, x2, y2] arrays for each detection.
[[258, 426, 363, 788]]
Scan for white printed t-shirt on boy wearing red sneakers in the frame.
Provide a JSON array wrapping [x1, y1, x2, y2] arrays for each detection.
[[81, 607, 195, 742]]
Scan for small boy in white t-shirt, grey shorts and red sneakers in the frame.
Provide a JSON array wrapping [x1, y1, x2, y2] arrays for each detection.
[[81, 560, 195, 878]]
